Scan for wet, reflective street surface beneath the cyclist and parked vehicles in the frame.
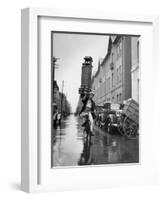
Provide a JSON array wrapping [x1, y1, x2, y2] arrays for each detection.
[[52, 115, 139, 167]]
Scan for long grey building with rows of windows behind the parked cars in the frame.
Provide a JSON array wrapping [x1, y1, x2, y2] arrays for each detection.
[[92, 35, 131, 105]]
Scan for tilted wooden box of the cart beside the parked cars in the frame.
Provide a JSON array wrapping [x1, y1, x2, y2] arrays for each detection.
[[123, 99, 139, 124]]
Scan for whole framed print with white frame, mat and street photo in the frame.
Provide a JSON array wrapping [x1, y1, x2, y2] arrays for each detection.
[[21, 8, 159, 192]]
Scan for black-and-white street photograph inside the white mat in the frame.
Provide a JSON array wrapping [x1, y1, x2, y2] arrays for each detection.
[[49, 31, 141, 168]]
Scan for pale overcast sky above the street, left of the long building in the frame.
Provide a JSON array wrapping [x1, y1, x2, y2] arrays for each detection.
[[53, 33, 109, 112]]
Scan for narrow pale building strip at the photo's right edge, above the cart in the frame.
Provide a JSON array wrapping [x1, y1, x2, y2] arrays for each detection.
[[131, 37, 140, 102]]
